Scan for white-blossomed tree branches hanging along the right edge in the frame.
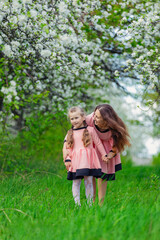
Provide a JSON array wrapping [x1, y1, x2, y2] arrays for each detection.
[[119, 0, 160, 135]]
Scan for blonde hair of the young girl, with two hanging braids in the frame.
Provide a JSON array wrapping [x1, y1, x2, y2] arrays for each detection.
[[67, 106, 91, 148]]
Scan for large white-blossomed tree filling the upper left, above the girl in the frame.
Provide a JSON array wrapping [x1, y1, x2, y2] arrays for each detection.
[[0, 0, 124, 129]]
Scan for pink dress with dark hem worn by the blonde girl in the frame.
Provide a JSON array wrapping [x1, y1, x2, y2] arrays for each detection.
[[65, 126, 106, 180]]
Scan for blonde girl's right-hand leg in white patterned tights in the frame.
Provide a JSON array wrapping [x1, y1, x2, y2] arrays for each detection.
[[84, 176, 93, 206]]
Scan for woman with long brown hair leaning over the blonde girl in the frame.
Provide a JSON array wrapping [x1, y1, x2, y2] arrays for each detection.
[[86, 104, 130, 204]]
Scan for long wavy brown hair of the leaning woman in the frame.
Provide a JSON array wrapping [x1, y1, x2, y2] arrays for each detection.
[[95, 104, 131, 152]]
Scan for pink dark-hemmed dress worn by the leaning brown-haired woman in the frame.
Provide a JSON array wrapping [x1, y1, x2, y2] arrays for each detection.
[[86, 113, 122, 181]]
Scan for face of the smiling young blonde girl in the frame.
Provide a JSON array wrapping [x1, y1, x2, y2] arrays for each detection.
[[69, 111, 85, 129]]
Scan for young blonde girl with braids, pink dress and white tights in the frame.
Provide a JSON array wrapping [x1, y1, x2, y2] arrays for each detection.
[[63, 107, 107, 206]]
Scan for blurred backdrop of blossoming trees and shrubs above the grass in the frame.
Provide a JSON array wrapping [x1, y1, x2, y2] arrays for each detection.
[[0, 0, 160, 173]]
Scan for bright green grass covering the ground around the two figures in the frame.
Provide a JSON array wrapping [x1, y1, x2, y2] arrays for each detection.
[[0, 166, 160, 240]]
